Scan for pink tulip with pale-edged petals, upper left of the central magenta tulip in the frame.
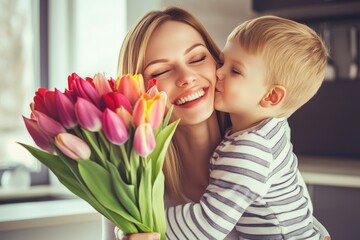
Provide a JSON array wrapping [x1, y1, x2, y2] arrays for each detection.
[[75, 97, 102, 132]]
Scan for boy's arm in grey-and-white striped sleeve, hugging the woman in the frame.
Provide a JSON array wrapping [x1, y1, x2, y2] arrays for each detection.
[[166, 142, 270, 240]]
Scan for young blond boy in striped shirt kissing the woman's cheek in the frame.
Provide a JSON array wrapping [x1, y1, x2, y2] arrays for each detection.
[[166, 16, 328, 240]]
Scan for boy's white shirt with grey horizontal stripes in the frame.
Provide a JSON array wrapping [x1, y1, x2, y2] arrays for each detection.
[[166, 118, 322, 240]]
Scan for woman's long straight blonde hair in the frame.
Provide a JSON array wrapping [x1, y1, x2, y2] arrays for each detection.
[[118, 7, 228, 203]]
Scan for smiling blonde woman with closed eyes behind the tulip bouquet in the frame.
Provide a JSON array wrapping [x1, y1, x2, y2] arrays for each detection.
[[103, 7, 233, 240]]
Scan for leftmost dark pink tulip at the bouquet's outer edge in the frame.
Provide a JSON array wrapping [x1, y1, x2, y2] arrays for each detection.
[[23, 116, 53, 152]]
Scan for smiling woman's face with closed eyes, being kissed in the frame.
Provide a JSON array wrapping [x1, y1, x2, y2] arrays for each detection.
[[143, 21, 216, 125]]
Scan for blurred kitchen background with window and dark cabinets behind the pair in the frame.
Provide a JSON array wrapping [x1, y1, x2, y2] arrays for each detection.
[[0, 0, 360, 240]]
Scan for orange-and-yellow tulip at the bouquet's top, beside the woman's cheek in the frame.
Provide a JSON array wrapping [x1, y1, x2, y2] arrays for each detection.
[[116, 74, 145, 106]]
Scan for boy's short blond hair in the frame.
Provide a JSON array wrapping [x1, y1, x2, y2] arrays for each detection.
[[228, 16, 328, 117]]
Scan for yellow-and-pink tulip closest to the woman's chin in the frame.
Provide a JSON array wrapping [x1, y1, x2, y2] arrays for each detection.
[[133, 93, 165, 130]]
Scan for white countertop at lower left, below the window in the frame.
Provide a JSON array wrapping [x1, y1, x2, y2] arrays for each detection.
[[0, 186, 101, 232]]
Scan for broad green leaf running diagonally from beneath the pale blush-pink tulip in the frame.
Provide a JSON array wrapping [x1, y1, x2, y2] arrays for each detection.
[[78, 160, 151, 232]]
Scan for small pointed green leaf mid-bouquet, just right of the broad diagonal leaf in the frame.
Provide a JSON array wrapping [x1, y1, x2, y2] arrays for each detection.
[[109, 163, 141, 221]]
